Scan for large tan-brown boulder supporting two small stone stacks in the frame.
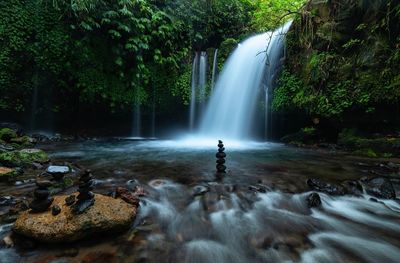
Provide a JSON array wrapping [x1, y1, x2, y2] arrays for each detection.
[[13, 194, 137, 243]]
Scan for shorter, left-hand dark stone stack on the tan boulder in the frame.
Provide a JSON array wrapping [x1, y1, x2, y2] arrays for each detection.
[[29, 180, 54, 213]]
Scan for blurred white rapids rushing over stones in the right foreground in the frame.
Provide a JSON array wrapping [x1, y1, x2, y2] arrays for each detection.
[[136, 183, 400, 263]]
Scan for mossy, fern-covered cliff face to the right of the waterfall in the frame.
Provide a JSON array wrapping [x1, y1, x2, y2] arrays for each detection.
[[273, 0, 400, 132]]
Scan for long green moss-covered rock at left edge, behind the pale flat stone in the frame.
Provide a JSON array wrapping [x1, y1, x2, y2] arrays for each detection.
[[0, 149, 50, 167]]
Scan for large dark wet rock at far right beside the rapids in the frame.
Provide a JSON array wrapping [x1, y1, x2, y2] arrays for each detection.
[[362, 177, 396, 199]]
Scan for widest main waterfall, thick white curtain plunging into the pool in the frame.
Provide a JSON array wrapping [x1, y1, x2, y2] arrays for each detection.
[[199, 22, 291, 140]]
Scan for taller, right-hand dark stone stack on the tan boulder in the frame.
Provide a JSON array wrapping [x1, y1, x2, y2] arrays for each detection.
[[73, 170, 94, 214]]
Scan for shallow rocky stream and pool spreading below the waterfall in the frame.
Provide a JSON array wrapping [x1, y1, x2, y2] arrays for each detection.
[[0, 136, 400, 262]]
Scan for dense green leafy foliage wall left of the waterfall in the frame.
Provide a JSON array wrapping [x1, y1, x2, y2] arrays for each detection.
[[0, 0, 304, 117]]
